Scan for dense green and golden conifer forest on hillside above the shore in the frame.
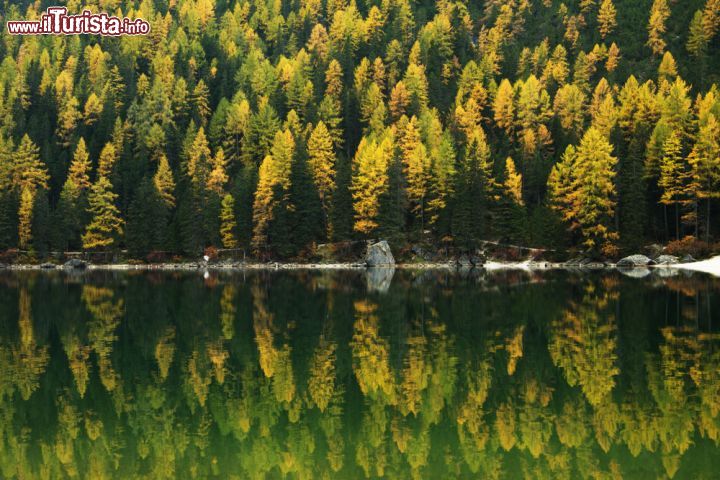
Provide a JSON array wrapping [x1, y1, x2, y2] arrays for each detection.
[[0, 0, 720, 259]]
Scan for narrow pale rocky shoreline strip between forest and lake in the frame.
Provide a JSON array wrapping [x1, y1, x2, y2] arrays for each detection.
[[0, 256, 720, 277]]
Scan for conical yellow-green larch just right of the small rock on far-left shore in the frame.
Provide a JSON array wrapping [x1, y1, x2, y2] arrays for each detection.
[[82, 176, 123, 250]]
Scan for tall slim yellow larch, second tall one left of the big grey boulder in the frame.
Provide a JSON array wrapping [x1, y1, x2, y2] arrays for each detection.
[[308, 121, 336, 238]]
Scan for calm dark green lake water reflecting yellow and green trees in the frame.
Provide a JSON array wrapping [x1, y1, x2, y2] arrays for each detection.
[[0, 271, 720, 479]]
